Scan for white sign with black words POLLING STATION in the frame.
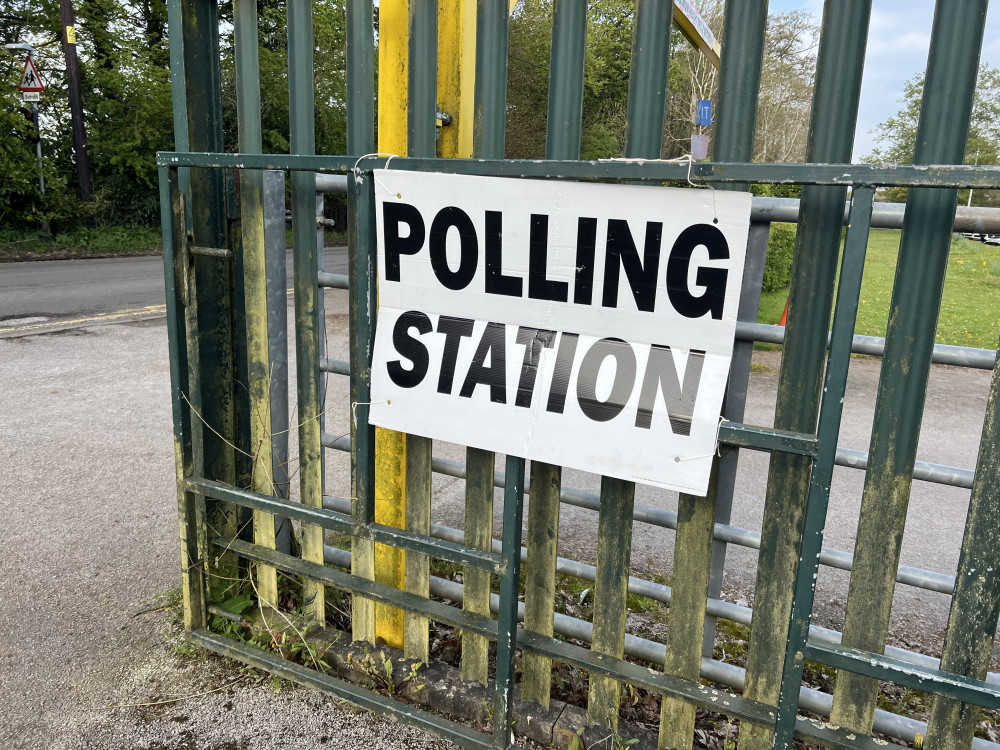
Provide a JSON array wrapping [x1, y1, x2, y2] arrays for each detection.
[[370, 169, 750, 495]]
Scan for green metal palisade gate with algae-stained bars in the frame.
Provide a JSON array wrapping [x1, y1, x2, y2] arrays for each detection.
[[158, 0, 1000, 748]]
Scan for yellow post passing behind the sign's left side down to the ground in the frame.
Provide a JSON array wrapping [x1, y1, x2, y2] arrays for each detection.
[[375, 0, 409, 649]]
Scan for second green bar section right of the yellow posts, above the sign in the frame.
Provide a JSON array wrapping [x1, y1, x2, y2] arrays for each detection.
[[545, 0, 587, 159]]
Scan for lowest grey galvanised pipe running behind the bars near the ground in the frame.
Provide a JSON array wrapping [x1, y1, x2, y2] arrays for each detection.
[[324, 532, 1000, 750]]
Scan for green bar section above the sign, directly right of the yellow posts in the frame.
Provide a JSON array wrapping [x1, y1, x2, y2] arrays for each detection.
[[472, 0, 510, 159]]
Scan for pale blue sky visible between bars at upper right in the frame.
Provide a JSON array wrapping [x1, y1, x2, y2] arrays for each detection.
[[768, 0, 1000, 161]]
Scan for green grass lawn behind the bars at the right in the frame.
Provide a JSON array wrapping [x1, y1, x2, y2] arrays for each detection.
[[758, 229, 1000, 349]]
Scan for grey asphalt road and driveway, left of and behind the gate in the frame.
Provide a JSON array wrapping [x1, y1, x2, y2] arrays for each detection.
[[0, 252, 990, 750]]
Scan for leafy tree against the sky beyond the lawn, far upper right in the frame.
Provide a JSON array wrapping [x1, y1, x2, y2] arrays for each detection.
[[864, 64, 1000, 206]]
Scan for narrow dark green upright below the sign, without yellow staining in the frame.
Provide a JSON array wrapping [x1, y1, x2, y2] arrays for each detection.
[[493, 456, 524, 750]]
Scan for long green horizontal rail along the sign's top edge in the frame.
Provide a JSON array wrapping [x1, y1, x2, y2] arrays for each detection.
[[156, 151, 1000, 190]]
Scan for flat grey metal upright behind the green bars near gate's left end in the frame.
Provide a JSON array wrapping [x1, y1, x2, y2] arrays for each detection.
[[264, 170, 292, 554]]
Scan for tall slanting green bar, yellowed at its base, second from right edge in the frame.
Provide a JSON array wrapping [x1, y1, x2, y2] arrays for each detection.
[[833, 0, 986, 732]]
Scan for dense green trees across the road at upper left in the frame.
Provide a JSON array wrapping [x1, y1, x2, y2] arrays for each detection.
[[0, 0, 346, 231]]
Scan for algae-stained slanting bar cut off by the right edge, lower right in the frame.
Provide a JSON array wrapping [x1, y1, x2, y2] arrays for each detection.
[[927, 338, 1000, 750]]
